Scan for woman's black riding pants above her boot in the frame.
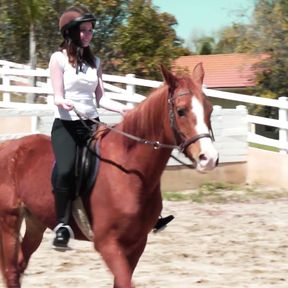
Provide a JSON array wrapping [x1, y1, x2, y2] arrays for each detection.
[[51, 118, 95, 197]]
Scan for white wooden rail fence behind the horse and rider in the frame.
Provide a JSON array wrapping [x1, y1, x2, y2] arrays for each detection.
[[0, 60, 288, 163]]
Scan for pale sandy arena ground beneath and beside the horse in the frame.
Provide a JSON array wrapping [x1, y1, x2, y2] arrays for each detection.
[[0, 187, 288, 288]]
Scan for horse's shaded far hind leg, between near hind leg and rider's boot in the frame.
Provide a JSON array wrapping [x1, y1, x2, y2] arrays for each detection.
[[18, 213, 46, 273]]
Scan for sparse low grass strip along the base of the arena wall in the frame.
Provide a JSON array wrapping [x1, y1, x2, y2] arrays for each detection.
[[163, 182, 288, 203]]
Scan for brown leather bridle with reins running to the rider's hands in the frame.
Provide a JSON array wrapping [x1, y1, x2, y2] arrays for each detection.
[[73, 85, 214, 153]]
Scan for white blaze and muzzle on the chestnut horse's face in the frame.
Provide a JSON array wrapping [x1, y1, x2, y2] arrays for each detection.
[[192, 96, 218, 172]]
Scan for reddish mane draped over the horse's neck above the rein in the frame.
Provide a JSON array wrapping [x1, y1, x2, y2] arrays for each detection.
[[122, 85, 168, 144]]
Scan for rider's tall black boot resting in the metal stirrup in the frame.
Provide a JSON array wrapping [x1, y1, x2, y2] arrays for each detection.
[[53, 189, 74, 250]]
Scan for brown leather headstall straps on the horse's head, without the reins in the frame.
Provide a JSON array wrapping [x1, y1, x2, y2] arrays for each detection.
[[168, 90, 214, 153]]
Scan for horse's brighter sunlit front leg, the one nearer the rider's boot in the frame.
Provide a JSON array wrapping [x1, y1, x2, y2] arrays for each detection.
[[97, 237, 132, 288]]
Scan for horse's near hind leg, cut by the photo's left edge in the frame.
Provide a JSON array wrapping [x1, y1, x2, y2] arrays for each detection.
[[0, 214, 21, 288]]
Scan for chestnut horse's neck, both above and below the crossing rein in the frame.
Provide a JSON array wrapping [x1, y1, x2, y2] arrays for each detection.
[[122, 92, 174, 169]]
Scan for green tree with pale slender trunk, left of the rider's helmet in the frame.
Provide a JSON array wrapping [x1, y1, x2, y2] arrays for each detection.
[[0, 0, 66, 67]]
